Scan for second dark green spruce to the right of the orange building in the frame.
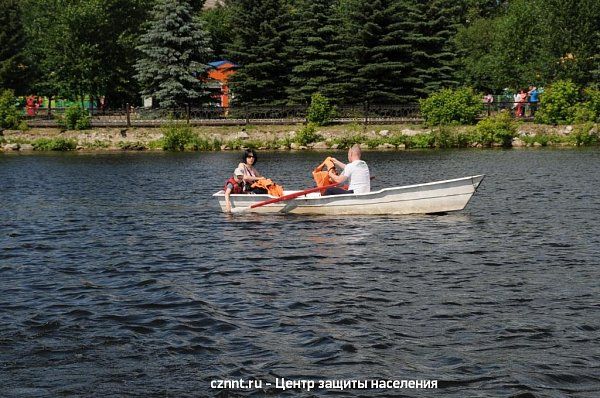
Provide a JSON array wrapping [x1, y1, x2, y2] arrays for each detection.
[[287, 0, 343, 104]]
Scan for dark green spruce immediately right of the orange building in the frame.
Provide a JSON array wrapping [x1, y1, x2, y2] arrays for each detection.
[[226, 0, 289, 105]]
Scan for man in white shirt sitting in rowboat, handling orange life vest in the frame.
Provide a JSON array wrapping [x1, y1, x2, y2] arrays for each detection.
[[324, 144, 371, 195]]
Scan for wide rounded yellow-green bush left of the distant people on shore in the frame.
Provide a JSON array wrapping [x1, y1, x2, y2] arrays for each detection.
[[419, 88, 483, 126]]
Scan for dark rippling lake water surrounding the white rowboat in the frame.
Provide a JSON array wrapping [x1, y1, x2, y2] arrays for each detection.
[[0, 148, 600, 398]]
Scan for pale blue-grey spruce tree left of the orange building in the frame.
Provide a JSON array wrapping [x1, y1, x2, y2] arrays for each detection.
[[136, 0, 211, 108]]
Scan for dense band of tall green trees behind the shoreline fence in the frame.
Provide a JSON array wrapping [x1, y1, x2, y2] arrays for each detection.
[[0, 0, 600, 107]]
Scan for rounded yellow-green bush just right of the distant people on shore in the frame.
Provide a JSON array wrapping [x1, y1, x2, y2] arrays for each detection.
[[535, 80, 580, 124]]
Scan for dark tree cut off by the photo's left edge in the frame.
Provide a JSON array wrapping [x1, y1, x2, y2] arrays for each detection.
[[0, 0, 27, 94]]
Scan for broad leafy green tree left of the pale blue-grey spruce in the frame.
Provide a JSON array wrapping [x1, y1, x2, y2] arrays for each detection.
[[23, 0, 153, 106]]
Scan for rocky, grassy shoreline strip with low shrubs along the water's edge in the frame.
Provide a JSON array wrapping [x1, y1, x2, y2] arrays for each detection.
[[0, 118, 600, 152]]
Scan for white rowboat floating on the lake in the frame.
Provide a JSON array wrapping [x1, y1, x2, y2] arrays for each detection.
[[213, 174, 485, 215]]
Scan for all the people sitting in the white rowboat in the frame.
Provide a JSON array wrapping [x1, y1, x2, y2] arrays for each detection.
[[223, 144, 371, 213]]
